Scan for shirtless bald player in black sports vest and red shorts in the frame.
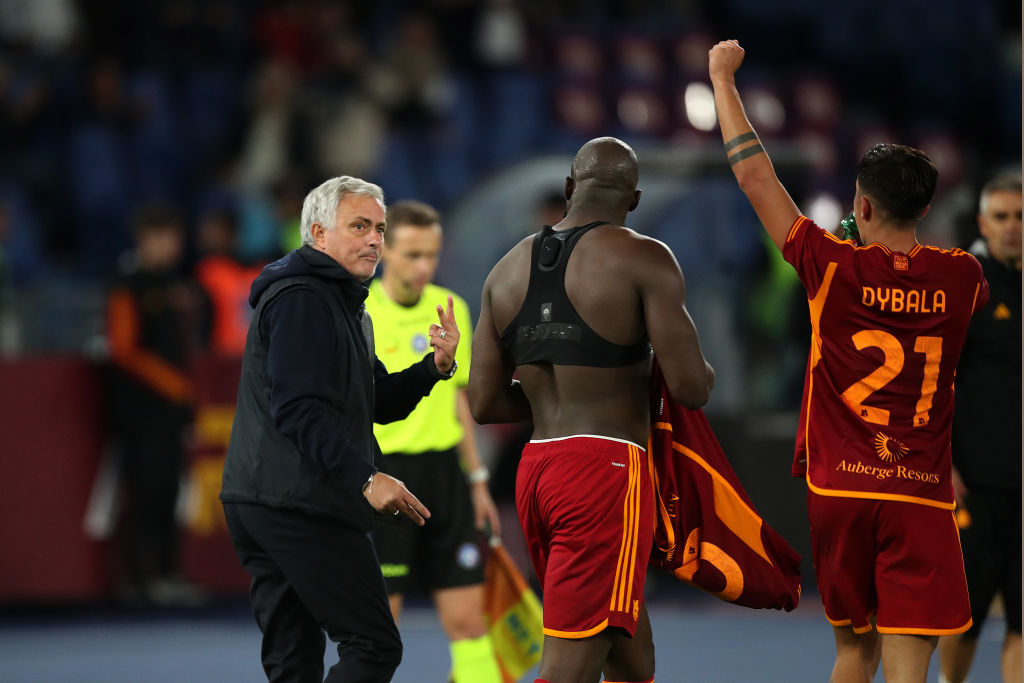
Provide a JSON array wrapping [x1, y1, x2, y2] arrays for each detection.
[[469, 137, 715, 683]]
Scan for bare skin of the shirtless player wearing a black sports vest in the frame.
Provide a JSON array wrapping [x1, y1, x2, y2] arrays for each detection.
[[469, 137, 715, 683]]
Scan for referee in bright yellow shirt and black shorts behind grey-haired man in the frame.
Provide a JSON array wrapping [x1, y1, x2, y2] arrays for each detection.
[[367, 201, 502, 683]]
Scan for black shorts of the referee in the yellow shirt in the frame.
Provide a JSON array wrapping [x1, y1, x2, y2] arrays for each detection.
[[374, 449, 483, 594]]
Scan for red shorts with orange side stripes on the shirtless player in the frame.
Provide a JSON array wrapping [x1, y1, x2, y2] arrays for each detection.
[[515, 436, 654, 638]]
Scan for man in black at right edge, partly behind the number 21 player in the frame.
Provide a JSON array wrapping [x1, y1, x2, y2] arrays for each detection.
[[939, 175, 1022, 683]]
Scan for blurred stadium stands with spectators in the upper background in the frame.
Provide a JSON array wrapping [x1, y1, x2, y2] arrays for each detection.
[[0, 0, 1021, 362]]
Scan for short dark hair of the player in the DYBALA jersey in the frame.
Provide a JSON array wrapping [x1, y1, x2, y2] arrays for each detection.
[[857, 144, 939, 223]]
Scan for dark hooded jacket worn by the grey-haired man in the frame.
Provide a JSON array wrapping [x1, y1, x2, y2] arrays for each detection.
[[220, 247, 441, 530]]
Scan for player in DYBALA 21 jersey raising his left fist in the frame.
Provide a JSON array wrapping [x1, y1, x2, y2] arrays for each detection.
[[709, 40, 988, 683]]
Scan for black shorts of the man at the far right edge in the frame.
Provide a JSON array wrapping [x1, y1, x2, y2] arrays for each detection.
[[957, 488, 1021, 637]]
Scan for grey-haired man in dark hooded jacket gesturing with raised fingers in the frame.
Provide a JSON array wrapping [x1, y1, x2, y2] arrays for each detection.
[[220, 176, 459, 683]]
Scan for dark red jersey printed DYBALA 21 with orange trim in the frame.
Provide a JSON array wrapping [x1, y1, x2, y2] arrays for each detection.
[[782, 216, 988, 509]]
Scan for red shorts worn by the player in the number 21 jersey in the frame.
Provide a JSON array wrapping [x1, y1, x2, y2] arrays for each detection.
[[807, 493, 971, 636]]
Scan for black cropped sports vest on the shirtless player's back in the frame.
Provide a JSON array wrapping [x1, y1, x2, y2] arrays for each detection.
[[502, 221, 650, 368]]
